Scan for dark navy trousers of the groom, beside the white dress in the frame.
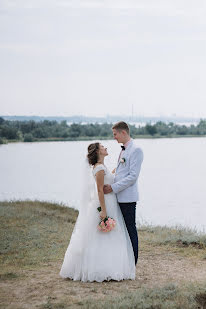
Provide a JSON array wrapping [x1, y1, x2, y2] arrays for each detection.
[[119, 202, 138, 265]]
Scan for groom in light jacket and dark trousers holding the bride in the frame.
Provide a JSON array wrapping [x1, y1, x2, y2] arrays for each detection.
[[104, 121, 143, 265]]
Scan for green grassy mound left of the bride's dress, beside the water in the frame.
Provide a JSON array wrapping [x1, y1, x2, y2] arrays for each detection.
[[0, 201, 78, 268]]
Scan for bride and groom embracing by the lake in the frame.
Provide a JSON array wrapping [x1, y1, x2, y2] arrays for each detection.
[[60, 121, 143, 282]]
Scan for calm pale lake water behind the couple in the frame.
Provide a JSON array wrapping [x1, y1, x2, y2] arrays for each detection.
[[0, 137, 206, 231]]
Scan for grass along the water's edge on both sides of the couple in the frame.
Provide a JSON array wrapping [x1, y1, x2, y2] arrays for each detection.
[[0, 201, 206, 267]]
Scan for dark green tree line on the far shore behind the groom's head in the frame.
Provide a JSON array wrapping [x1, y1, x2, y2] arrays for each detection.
[[0, 117, 206, 144]]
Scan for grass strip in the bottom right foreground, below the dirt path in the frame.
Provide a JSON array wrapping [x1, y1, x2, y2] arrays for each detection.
[[75, 284, 206, 309]]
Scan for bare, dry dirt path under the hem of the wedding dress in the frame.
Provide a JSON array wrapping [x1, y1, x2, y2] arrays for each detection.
[[0, 246, 206, 309]]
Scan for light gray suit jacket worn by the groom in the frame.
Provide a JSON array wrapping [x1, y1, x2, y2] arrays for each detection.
[[111, 140, 143, 203]]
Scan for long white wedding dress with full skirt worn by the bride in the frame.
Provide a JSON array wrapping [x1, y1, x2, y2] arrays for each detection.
[[59, 164, 135, 282]]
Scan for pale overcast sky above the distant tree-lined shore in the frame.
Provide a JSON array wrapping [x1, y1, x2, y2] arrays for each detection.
[[0, 0, 206, 117]]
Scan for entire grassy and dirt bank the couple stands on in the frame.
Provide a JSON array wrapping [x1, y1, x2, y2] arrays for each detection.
[[0, 201, 206, 309]]
